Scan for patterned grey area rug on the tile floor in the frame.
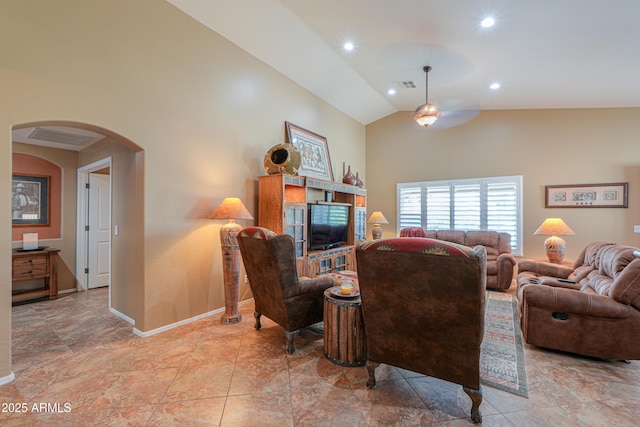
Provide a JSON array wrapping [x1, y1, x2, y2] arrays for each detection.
[[480, 291, 529, 398]]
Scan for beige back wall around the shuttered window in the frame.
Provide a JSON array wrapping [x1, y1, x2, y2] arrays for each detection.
[[366, 108, 640, 259]]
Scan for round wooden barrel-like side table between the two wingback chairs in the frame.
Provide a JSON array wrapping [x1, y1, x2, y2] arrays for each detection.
[[324, 288, 367, 366]]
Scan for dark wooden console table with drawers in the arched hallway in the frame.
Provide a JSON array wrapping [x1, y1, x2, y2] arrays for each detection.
[[11, 248, 60, 302]]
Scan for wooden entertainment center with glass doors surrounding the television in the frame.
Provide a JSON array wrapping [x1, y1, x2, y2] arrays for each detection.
[[258, 174, 367, 277]]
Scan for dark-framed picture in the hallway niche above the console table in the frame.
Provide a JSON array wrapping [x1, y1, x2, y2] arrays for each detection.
[[11, 175, 50, 227]]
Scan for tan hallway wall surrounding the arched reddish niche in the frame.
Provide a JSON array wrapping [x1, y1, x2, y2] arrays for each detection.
[[12, 142, 78, 292]]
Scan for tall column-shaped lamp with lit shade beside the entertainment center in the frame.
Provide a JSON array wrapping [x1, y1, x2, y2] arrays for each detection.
[[211, 197, 253, 323]]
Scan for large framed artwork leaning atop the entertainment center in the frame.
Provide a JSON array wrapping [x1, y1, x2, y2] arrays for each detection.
[[284, 122, 333, 181]]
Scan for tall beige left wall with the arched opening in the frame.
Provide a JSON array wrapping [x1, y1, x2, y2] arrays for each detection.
[[0, 0, 367, 378]]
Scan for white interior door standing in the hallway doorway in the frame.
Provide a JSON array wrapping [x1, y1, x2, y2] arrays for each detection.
[[87, 173, 111, 289]]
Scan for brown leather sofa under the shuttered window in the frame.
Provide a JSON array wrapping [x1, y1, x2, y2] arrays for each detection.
[[400, 227, 516, 290]]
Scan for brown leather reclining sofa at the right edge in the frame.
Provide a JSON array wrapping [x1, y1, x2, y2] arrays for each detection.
[[517, 242, 640, 360]]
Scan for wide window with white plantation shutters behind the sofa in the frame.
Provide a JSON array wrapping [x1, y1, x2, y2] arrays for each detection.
[[397, 175, 522, 255]]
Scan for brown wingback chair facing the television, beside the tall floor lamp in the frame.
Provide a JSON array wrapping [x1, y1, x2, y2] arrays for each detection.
[[237, 227, 334, 354]]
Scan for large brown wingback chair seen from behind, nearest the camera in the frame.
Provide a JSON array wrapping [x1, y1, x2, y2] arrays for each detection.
[[356, 237, 487, 423]]
